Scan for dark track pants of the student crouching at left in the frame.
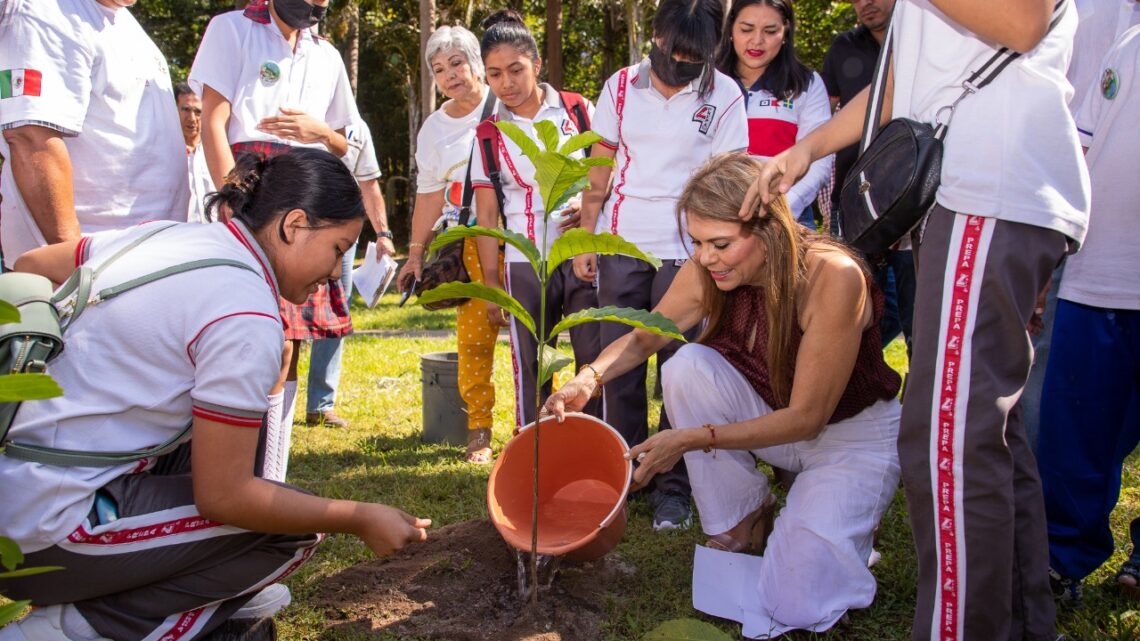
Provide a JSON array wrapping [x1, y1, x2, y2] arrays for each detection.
[[0, 460, 320, 641]]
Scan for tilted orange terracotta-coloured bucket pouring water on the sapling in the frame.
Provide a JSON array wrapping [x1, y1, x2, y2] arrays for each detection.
[[487, 413, 633, 561]]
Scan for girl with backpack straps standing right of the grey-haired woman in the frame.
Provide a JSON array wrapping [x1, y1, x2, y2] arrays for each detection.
[[471, 9, 602, 428]]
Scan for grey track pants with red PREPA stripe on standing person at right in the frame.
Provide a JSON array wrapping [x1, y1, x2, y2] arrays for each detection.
[[898, 205, 1067, 641]]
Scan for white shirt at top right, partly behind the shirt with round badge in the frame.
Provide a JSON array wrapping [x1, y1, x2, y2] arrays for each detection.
[[1067, 0, 1140, 106]]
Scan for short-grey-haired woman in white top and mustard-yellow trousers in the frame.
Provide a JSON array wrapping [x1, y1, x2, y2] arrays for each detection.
[[397, 26, 498, 464]]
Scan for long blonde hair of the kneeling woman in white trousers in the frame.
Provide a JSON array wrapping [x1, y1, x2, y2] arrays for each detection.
[[677, 152, 857, 406]]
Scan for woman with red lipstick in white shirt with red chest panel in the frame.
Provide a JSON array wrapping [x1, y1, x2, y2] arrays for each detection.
[[716, 0, 834, 229]]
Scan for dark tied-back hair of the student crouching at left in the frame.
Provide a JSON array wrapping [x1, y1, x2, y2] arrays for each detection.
[[206, 147, 365, 234]]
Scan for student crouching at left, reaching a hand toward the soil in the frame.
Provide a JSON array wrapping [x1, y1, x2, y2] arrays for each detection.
[[0, 149, 430, 641]]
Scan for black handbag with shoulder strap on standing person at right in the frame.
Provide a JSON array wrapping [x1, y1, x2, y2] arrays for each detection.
[[839, 0, 1066, 253]]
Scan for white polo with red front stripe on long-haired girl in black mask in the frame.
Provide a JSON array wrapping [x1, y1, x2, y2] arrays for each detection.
[[591, 58, 748, 260]]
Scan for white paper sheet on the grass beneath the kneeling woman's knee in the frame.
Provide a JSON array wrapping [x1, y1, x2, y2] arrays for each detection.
[[693, 545, 842, 639]]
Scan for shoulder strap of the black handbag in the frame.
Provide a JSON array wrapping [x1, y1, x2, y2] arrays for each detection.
[[860, 0, 1069, 153]]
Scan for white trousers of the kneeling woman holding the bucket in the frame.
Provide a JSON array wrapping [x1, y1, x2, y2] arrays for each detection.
[[661, 343, 899, 628]]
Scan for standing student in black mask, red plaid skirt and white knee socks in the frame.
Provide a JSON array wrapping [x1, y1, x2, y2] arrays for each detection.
[[188, 0, 359, 526]]
